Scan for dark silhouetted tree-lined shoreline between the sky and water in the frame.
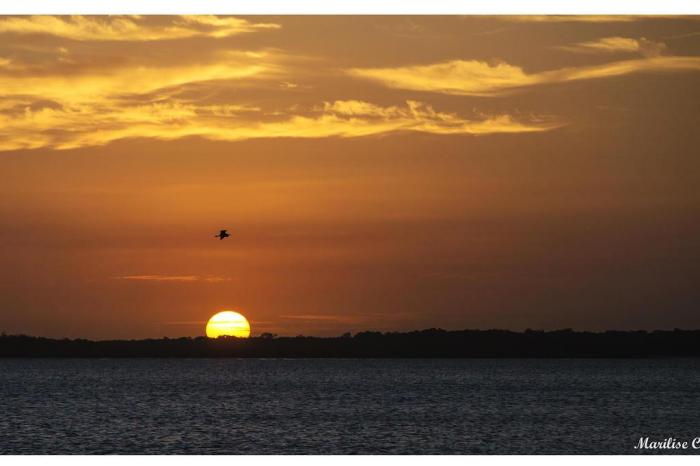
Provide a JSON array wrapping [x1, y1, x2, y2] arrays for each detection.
[[0, 329, 700, 358]]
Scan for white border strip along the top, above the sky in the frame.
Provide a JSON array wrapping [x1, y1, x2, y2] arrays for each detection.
[[0, 0, 700, 15]]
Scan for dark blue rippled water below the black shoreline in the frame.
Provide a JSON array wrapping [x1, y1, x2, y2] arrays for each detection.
[[0, 359, 700, 454]]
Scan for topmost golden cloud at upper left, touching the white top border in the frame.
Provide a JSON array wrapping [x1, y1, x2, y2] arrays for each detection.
[[0, 16, 280, 41]]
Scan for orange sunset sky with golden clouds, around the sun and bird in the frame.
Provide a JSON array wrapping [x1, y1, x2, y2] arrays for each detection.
[[0, 16, 700, 339]]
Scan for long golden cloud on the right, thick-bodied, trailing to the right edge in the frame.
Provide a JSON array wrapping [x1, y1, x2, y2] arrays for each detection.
[[346, 56, 700, 96]]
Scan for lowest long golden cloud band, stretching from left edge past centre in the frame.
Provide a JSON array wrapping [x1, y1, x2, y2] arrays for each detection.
[[0, 100, 562, 150]]
